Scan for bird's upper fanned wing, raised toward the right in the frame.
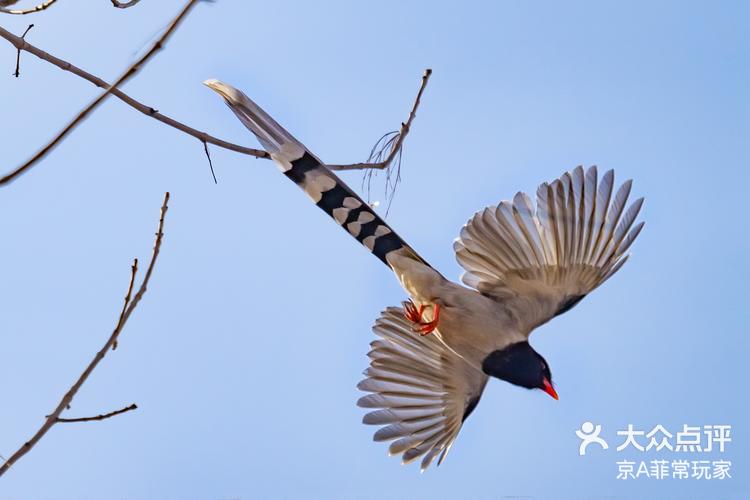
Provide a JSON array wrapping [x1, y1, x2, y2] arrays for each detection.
[[453, 167, 643, 332]]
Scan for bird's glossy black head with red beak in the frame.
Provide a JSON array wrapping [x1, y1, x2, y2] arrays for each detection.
[[482, 342, 557, 399]]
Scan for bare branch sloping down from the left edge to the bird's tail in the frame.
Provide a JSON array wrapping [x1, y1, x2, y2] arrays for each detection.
[[0, 26, 270, 159]]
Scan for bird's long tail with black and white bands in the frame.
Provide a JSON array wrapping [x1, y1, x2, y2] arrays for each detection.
[[204, 80, 426, 265]]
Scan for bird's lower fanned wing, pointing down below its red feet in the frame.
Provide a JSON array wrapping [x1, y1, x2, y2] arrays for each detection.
[[357, 307, 487, 471]]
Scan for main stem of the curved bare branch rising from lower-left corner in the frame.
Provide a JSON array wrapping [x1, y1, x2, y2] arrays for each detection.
[[0, 193, 169, 476]]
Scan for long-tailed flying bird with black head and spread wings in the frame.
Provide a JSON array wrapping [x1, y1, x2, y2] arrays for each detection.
[[204, 80, 644, 472]]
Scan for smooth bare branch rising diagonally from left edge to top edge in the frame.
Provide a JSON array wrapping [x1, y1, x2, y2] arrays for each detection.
[[0, 0, 198, 185]]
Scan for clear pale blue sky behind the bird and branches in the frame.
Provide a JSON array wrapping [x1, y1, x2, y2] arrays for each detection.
[[0, 0, 750, 500]]
